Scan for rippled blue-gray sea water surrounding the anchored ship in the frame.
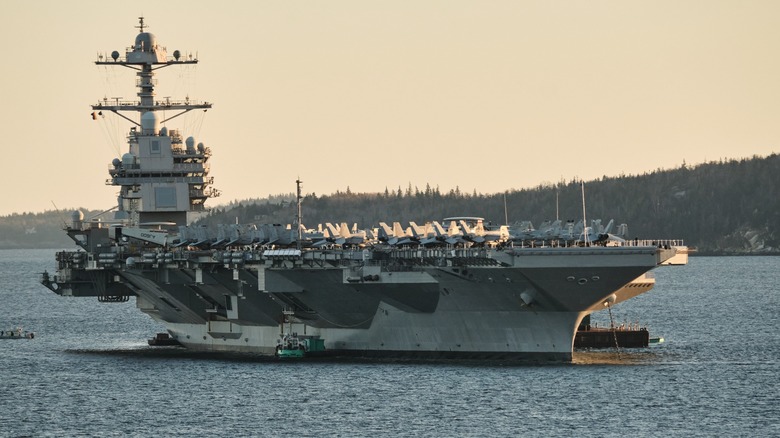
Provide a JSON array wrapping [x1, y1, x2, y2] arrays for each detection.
[[0, 250, 780, 436]]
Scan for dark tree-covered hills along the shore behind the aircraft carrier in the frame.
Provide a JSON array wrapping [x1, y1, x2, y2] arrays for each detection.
[[0, 154, 780, 254]]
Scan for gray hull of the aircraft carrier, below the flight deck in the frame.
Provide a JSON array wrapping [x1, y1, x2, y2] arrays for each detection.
[[45, 247, 674, 360]]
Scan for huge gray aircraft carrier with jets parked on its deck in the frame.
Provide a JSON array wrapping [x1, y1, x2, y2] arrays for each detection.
[[41, 19, 687, 361]]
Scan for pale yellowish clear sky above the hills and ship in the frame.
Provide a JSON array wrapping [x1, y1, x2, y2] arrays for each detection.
[[0, 0, 780, 215]]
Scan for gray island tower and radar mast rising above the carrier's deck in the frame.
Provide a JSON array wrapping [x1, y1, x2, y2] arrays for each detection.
[[97, 17, 219, 226]]
